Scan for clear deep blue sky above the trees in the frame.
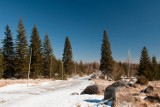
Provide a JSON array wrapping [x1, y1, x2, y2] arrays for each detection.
[[0, 0, 160, 62]]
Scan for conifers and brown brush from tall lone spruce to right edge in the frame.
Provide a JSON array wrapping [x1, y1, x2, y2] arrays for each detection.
[[100, 31, 160, 84]]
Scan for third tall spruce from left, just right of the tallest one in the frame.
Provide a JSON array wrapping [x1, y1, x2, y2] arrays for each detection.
[[30, 26, 43, 78]]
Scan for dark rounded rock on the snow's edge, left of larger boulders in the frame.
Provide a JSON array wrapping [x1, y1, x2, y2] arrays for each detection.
[[81, 85, 99, 94]]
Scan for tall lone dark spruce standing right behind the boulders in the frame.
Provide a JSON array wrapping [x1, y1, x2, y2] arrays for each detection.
[[100, 31, 113, 78]]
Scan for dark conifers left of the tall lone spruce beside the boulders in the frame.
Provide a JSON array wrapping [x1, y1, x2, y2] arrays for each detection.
[[0, 19, 99, 79]]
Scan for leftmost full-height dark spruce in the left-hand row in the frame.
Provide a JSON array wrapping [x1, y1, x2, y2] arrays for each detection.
[[2, 25, 15, 78]]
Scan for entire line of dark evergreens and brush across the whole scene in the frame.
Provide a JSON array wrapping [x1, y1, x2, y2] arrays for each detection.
[[0, 19, 160, 82]]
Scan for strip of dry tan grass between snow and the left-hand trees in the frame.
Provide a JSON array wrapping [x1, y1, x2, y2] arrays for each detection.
[[0, 79, 52, 87]]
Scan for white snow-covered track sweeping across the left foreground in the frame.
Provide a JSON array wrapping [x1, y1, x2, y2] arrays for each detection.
[[0, 77, 110, 107]]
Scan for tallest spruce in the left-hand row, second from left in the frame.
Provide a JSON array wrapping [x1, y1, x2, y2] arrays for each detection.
[[16, 19, 29, 78]]
